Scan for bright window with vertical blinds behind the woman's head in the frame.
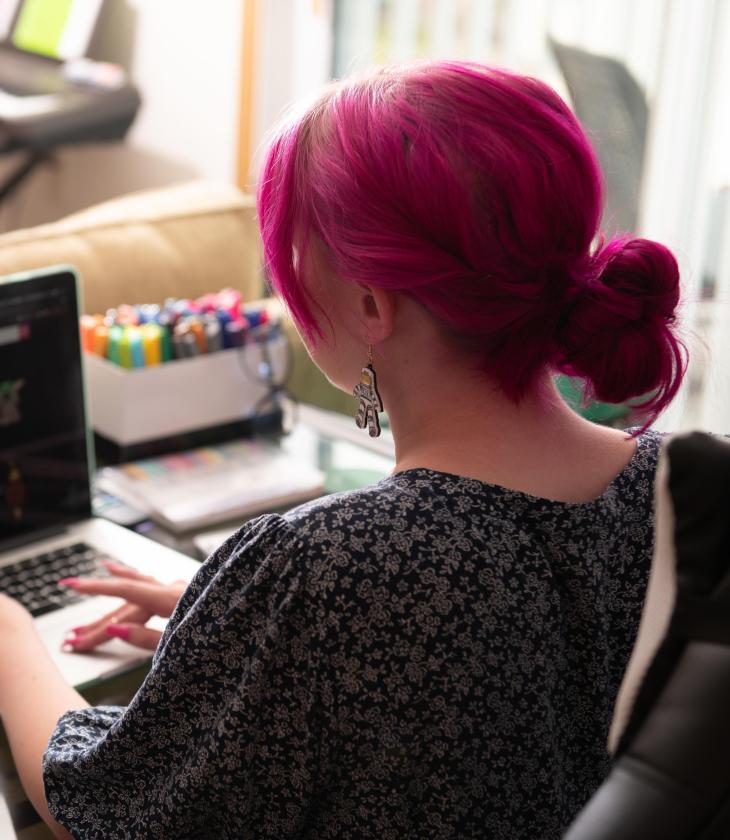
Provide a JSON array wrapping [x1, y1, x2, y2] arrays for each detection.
[[255, 0, 730, 432]]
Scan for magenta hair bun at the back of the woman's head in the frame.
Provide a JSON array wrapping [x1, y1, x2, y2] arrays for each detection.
[[558, 237, 686, 410]]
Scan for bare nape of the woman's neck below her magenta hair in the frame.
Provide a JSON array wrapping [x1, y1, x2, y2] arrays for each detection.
[[383, 360, 635, 501]]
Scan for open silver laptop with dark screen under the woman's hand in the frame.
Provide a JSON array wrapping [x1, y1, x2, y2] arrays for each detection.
[[0, 267, 200, 688]]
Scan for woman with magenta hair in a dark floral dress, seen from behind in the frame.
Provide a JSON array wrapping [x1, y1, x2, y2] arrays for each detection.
[[0, 62, 684, 840]]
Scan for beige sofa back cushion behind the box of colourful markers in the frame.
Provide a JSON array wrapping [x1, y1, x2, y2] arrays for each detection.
[[0, 181, 263, 312]]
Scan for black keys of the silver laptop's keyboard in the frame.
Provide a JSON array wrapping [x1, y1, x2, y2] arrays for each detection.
[[0, 543, 110, 616]]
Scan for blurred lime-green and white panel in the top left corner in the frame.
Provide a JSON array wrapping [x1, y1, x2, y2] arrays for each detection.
[[0, 0, 102, 61]]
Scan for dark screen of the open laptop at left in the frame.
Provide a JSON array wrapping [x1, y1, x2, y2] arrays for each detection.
[[0, 270, 91, 542]]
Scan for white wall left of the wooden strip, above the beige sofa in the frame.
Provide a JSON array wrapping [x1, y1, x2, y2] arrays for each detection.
[[0, 0, 249, 231]]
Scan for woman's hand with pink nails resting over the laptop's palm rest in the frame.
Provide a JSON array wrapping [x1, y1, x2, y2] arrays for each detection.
[[59, 562, 187, 653]]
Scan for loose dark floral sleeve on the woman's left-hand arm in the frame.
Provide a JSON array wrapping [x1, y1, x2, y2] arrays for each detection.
[[43, 515, 321, 840]]
